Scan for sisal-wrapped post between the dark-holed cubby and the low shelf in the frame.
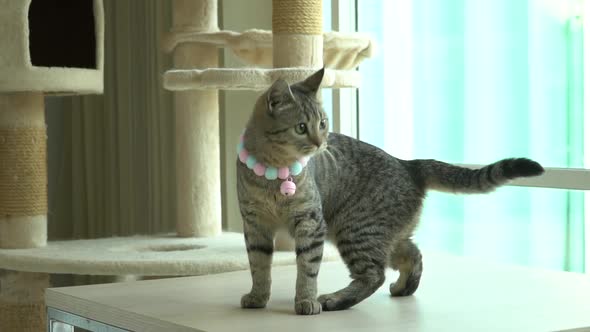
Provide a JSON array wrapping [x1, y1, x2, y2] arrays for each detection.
[[0, 92, 47, 248]]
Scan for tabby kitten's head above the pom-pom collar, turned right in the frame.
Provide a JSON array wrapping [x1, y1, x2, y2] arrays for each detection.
[[249, 68, 328, 166]]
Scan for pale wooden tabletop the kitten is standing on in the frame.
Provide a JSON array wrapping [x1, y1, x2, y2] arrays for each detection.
[[46, 253, 590, 332]]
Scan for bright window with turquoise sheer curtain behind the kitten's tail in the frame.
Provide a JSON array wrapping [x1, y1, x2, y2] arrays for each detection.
[[332, 0, 590, 271]]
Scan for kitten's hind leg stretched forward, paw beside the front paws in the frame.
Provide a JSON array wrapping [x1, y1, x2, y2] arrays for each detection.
[[318, 234, 387, 311]]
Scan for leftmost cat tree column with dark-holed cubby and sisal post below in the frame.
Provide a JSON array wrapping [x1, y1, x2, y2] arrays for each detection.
[[0, 0, 104, 331]]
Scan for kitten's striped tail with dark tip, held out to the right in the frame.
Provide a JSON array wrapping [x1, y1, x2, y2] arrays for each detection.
[[407, 158, 545, 194]]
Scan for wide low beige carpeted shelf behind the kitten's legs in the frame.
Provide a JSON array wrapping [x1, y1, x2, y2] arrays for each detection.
[[0, 233, 339, 276]]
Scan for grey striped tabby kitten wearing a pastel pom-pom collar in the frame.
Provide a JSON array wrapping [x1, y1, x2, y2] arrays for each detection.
[[237, 69, 543, 315]]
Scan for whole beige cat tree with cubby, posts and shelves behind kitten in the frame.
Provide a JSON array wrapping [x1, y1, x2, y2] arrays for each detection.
[[0, 0, 373, 331]]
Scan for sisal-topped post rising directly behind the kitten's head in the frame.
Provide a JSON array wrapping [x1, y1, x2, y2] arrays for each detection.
[[272, 0, 324, 251]]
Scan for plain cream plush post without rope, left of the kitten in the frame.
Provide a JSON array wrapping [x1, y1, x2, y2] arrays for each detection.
[[173, 0, 221, 237]]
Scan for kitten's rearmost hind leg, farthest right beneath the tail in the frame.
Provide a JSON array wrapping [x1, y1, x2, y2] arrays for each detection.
[[389, 239, 422, 296]]
